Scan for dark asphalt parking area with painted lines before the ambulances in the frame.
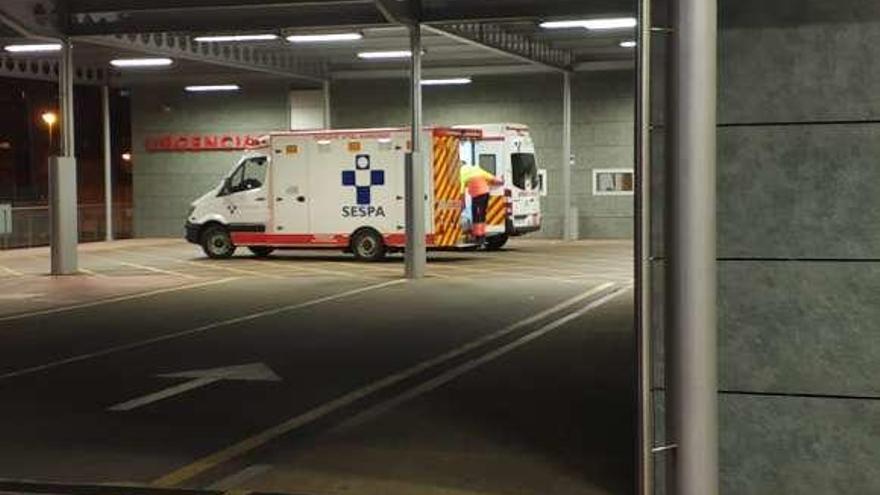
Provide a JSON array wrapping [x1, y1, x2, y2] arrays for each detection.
[[0, 241, 635, 495]]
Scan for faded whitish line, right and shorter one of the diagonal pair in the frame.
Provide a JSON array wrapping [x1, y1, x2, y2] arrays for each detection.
[[335, 287, 628, 430]]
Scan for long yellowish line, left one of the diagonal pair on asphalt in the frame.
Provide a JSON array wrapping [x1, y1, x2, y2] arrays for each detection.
[[151, 283, 614, 488]]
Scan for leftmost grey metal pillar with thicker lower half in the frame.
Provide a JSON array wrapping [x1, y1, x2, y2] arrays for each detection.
[[49, 40, 79, 275]]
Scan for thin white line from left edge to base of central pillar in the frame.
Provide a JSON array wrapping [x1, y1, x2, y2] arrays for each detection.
[[0, 279, 405, 380]]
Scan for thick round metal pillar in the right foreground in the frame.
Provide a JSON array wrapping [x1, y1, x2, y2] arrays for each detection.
[[666, 0, 718, 495]]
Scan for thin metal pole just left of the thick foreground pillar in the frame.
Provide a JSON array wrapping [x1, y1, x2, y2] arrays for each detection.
[[635, 0, 654, 495]]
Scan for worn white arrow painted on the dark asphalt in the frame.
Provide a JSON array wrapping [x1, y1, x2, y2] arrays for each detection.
[[107, 363, 281, 411]]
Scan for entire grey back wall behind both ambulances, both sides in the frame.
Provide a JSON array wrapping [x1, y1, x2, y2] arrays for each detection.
[[132, 72, 633, 238]]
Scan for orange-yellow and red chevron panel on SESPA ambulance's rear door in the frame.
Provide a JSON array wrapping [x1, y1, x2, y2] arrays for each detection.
[[432, 135, 462, 247]]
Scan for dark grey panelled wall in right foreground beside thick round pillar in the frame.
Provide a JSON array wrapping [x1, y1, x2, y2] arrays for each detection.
[[655, 0, 880, 495]]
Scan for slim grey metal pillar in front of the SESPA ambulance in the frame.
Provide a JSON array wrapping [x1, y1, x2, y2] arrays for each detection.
[[405, 24, 427, 279]]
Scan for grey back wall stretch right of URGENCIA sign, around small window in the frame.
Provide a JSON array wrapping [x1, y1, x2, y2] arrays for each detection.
[[332, 71, 634, 238]]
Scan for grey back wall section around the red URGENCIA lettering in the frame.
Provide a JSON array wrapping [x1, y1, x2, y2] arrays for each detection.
[[131, 83, 289, 237]]
